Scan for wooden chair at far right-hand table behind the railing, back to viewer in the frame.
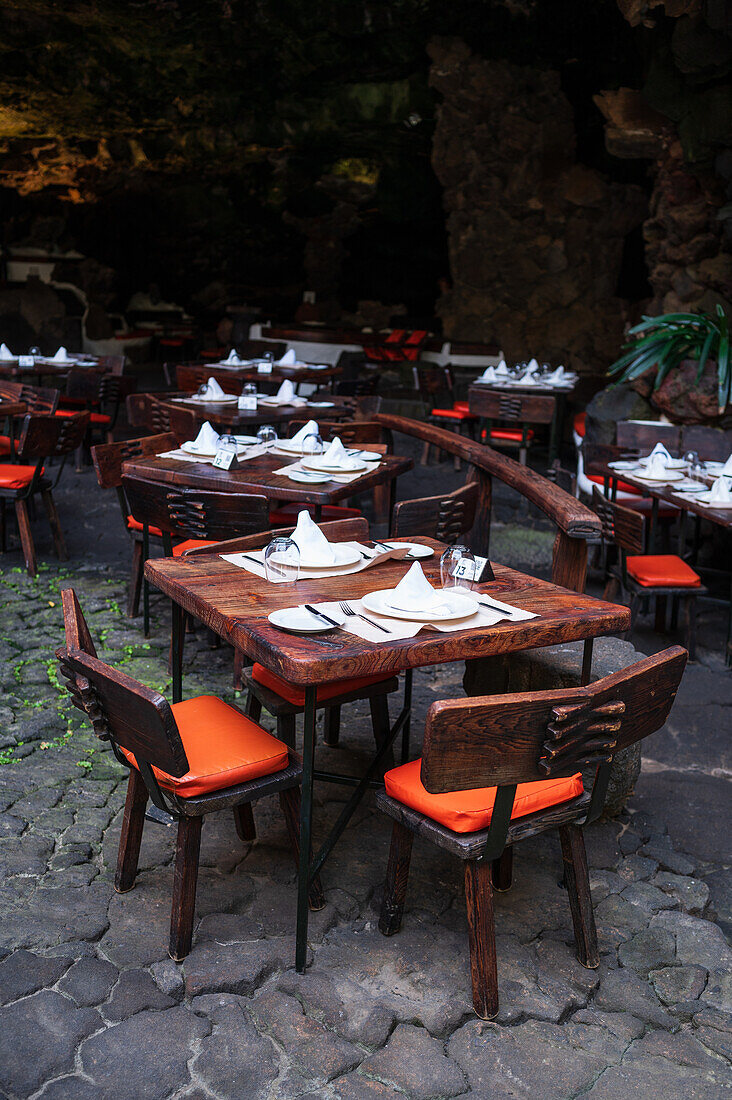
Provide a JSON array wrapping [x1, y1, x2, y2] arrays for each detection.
[[470, 386, 557, 466]]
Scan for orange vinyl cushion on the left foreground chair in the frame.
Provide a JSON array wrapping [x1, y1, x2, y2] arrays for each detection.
[[122, 695, 288, 799]]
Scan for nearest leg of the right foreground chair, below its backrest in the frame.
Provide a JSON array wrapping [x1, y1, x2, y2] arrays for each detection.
[[465, 859, 499, 1020]]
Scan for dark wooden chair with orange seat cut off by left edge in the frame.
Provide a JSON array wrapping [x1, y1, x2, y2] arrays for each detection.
[[0, 413, 89, 576]]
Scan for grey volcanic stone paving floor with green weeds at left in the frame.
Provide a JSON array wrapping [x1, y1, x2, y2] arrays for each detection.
[[0, 457, 732, 1100]]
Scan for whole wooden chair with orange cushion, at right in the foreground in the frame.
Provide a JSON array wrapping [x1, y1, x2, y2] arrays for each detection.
[[376, 646, 687, 1020]]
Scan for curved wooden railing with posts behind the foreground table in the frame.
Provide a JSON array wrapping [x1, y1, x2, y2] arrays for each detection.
[[374, 413, 601, 592]]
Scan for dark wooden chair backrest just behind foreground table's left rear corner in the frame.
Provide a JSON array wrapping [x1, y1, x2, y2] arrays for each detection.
[[122, 477, 270, 539]]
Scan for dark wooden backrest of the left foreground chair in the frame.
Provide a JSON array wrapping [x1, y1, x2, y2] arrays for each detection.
[[62, 649, 188, 779]]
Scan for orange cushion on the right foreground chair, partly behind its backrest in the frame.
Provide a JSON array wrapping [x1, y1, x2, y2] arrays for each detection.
[[384, 760, 584, 833]]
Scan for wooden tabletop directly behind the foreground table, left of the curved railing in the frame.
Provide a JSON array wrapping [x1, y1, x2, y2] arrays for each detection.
[[122, 453, 414, 520]]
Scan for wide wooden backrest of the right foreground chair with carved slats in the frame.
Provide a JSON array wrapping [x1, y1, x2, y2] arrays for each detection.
[[422, 646, 688, 794]]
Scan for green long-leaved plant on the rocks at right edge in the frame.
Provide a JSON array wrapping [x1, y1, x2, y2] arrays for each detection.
[[608, 305, 732, 413]]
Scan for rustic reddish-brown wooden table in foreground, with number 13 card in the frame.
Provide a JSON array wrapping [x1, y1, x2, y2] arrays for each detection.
[[145, 538, 630, 971]]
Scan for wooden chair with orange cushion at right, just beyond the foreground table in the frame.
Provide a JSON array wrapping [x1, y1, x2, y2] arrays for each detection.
[[592, 485, 707, 660]]
